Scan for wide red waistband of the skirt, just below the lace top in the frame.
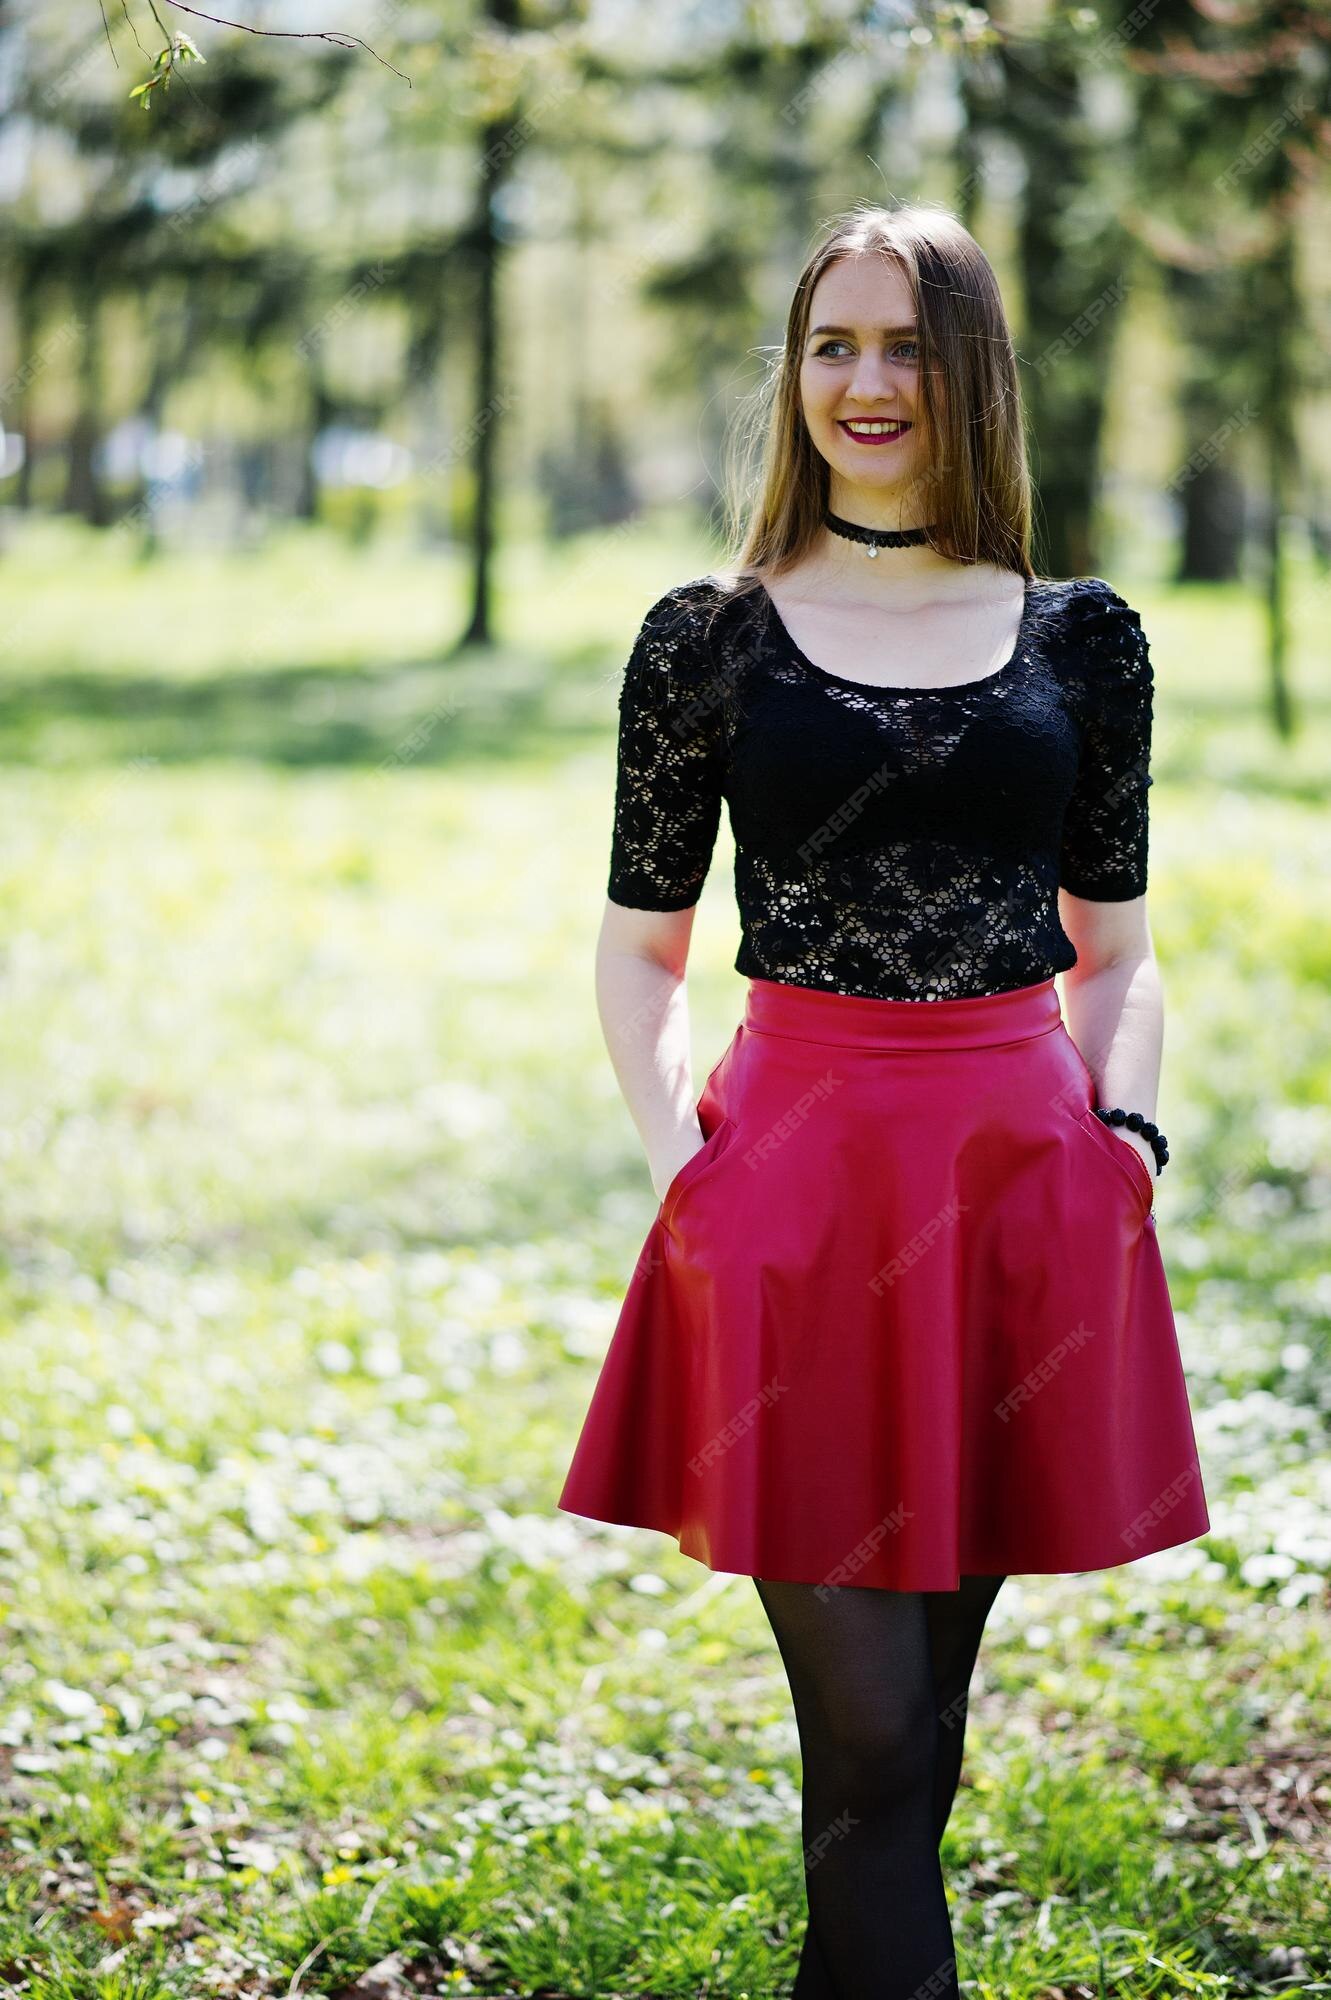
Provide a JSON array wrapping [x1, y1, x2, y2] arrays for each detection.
[[743, 976, 1063, 1048]]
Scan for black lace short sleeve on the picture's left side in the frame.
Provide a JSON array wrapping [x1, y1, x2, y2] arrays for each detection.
[[608, 584, 725, 910]]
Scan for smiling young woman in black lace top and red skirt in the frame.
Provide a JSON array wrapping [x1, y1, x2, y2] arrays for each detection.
[[558, 206, 1209, 2000]]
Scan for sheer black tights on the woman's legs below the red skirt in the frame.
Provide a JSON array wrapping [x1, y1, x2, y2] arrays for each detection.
[[753, 1576, 1003, 2000]]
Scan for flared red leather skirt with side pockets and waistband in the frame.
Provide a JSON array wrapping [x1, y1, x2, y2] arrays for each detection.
[[558, 978, 1211, 1590]]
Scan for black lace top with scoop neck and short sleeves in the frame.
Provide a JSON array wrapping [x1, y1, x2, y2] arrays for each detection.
[[608, 576, 1153, 1000]]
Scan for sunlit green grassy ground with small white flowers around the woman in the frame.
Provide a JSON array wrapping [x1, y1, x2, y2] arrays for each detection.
[[0, 526, 1331, 2000]]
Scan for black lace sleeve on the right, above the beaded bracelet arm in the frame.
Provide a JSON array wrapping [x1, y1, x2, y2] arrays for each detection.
[[1059, 578, 1155, 902]]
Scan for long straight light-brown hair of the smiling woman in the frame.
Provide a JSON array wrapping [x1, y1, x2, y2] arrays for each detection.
[[715, 202, 1035, 594]]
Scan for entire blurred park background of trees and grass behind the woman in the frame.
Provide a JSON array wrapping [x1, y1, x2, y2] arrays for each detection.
[[0, 0, 1331, 2000]]
